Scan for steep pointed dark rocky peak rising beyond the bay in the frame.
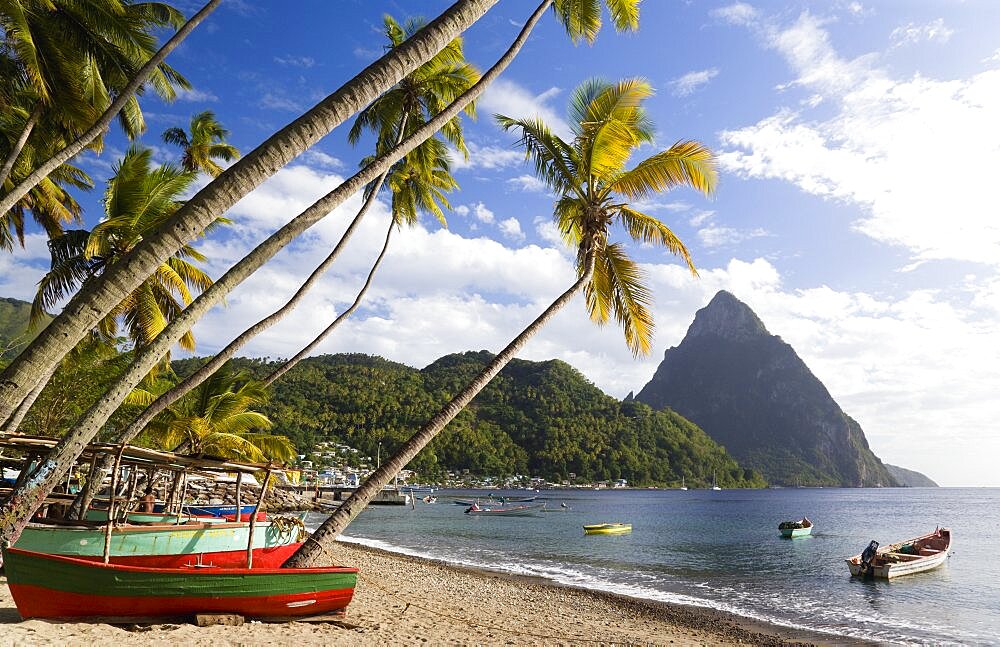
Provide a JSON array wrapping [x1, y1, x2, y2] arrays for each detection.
[[635, 291, 896, 486]]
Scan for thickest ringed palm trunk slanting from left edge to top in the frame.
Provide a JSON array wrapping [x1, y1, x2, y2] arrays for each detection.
[[0, 0, 498, 426]]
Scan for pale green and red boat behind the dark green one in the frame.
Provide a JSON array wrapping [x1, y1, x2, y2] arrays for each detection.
[[14, 520, 301, 568]]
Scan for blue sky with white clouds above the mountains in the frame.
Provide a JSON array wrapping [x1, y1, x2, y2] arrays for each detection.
[[0, 0, 1000, 486]]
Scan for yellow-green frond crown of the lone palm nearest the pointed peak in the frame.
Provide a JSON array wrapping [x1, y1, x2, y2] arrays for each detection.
[[496, 79, 717, 355]]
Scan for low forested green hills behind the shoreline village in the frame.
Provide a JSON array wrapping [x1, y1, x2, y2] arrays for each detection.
[[174, 351, 764, 487]]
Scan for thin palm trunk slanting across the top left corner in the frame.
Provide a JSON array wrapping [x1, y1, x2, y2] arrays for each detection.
[[0, 0, 222, 213]]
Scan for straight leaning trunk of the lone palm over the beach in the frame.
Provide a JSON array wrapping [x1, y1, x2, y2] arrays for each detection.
[[284, 254, 594, 568]]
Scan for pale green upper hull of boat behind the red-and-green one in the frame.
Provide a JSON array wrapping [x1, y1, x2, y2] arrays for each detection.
[[14, 522, 298, 561]]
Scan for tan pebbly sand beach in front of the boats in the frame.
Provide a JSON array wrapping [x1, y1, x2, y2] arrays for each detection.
[[0, 543, 868, 645]]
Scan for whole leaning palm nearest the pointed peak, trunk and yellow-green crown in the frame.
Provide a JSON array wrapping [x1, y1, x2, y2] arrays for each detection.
[[286, 79, 716, 567]]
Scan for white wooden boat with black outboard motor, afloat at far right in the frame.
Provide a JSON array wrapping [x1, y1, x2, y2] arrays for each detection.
[[846, 528, 952, 579]]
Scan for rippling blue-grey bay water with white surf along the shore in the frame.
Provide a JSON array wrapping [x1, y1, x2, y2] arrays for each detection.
[[307, 488, 1000, 645]]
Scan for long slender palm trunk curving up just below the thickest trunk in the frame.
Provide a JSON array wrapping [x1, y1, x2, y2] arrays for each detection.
[[0, 0, 552, 543]]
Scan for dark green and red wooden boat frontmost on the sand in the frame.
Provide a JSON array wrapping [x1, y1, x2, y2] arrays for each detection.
[[4, 548, 358, 622]]
